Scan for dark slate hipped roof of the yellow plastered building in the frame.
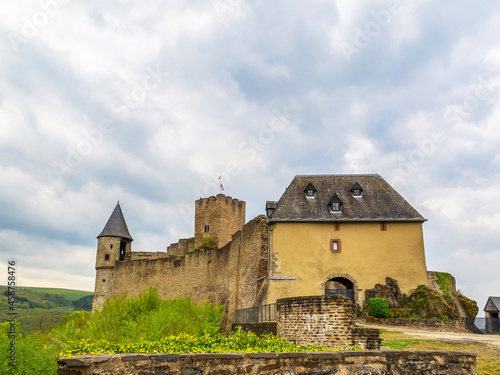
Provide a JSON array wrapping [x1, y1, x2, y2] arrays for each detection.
[[268, 174, 426, 222]]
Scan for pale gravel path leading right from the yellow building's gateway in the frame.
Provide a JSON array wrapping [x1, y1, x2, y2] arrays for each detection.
[[358, 322, 500, 349]]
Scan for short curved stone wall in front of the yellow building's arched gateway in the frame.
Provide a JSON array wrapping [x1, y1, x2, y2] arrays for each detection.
[[276, 295, 355, 348]]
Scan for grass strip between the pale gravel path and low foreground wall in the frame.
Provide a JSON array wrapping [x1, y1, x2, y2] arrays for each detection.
[[380, 329, 500, 375]]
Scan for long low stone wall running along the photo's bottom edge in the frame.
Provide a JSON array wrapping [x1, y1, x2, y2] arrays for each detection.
[[57, 351, 476, 375]]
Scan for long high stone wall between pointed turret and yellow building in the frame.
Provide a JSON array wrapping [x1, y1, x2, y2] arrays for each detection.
[[111, 216, 267, 330]]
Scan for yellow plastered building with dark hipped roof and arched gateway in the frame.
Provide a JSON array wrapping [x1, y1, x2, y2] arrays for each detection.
[[258, 174, 427, 306]]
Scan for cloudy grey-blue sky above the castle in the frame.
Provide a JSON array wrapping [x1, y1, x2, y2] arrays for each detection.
[[0, 0, 500, 316]]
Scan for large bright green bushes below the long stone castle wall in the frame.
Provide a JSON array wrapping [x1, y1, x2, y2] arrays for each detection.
[[54, 288, 223, 344]]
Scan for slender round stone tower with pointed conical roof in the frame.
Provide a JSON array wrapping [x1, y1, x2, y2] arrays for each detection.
[[92, 202, 133, 310]]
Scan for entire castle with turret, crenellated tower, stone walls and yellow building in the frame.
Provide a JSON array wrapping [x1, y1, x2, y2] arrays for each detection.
[[94, 174, 427, 324]]
